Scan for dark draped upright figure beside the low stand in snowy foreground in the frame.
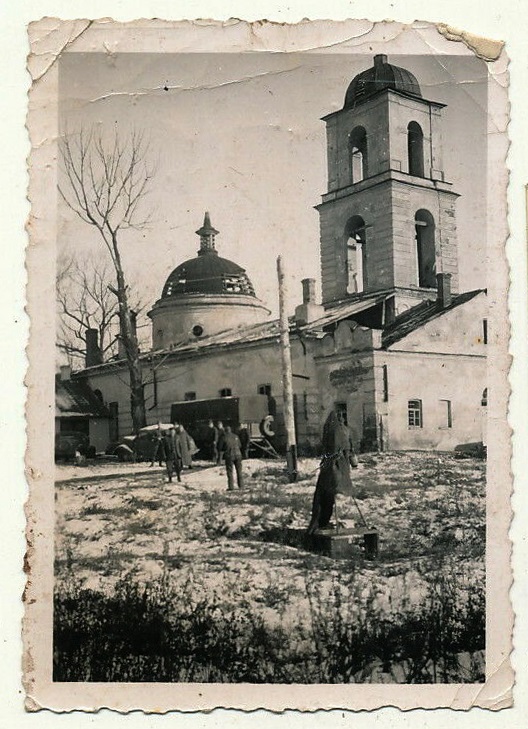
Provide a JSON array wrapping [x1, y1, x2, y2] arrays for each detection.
[[308, 410, 358, 534]]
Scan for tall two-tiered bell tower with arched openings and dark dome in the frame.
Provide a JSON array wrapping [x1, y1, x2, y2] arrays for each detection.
[[317, 55, 458, 313]]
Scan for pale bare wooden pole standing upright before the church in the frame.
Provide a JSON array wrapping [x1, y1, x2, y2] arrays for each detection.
[[277, 256, 297, 483]]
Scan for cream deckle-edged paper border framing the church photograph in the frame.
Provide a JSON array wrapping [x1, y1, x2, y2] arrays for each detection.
[[25, 18, 513, 711]]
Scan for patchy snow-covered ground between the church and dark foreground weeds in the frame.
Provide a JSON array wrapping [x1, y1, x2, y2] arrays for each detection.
[[56, 453, 485, 680]]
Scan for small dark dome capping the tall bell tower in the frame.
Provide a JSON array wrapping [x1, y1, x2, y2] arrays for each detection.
[[343, 54, 422, 109]]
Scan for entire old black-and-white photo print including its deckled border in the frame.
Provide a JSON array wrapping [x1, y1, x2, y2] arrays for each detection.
[[24, 18, 514, 712]]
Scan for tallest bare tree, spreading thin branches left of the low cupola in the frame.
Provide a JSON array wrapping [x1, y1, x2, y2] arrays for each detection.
[[59, 129, 153, 431]]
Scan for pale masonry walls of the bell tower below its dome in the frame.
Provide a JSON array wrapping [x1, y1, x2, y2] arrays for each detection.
[[318, 91, 458, 303]]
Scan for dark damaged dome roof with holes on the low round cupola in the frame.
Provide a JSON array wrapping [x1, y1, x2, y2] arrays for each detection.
[[162, 251, 255, 298]]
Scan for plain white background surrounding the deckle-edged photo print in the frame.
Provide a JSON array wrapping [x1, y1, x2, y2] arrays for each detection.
[[1, 0, 527, 727]]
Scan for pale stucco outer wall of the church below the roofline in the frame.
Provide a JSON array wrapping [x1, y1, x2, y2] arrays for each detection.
[[81, 294, 487, 449]]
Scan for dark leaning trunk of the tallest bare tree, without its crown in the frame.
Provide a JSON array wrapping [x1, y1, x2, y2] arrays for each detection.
[[114, 247, 147, 433]]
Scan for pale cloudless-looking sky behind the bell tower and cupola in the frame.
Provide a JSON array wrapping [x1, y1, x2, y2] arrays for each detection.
[[59, 52, 487, 312]]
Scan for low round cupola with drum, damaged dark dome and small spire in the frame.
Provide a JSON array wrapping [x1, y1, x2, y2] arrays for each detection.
[[148, 212, 270, 349]]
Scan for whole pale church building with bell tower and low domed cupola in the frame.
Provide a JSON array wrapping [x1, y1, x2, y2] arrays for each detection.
[[75, 55, 487, 453]]
